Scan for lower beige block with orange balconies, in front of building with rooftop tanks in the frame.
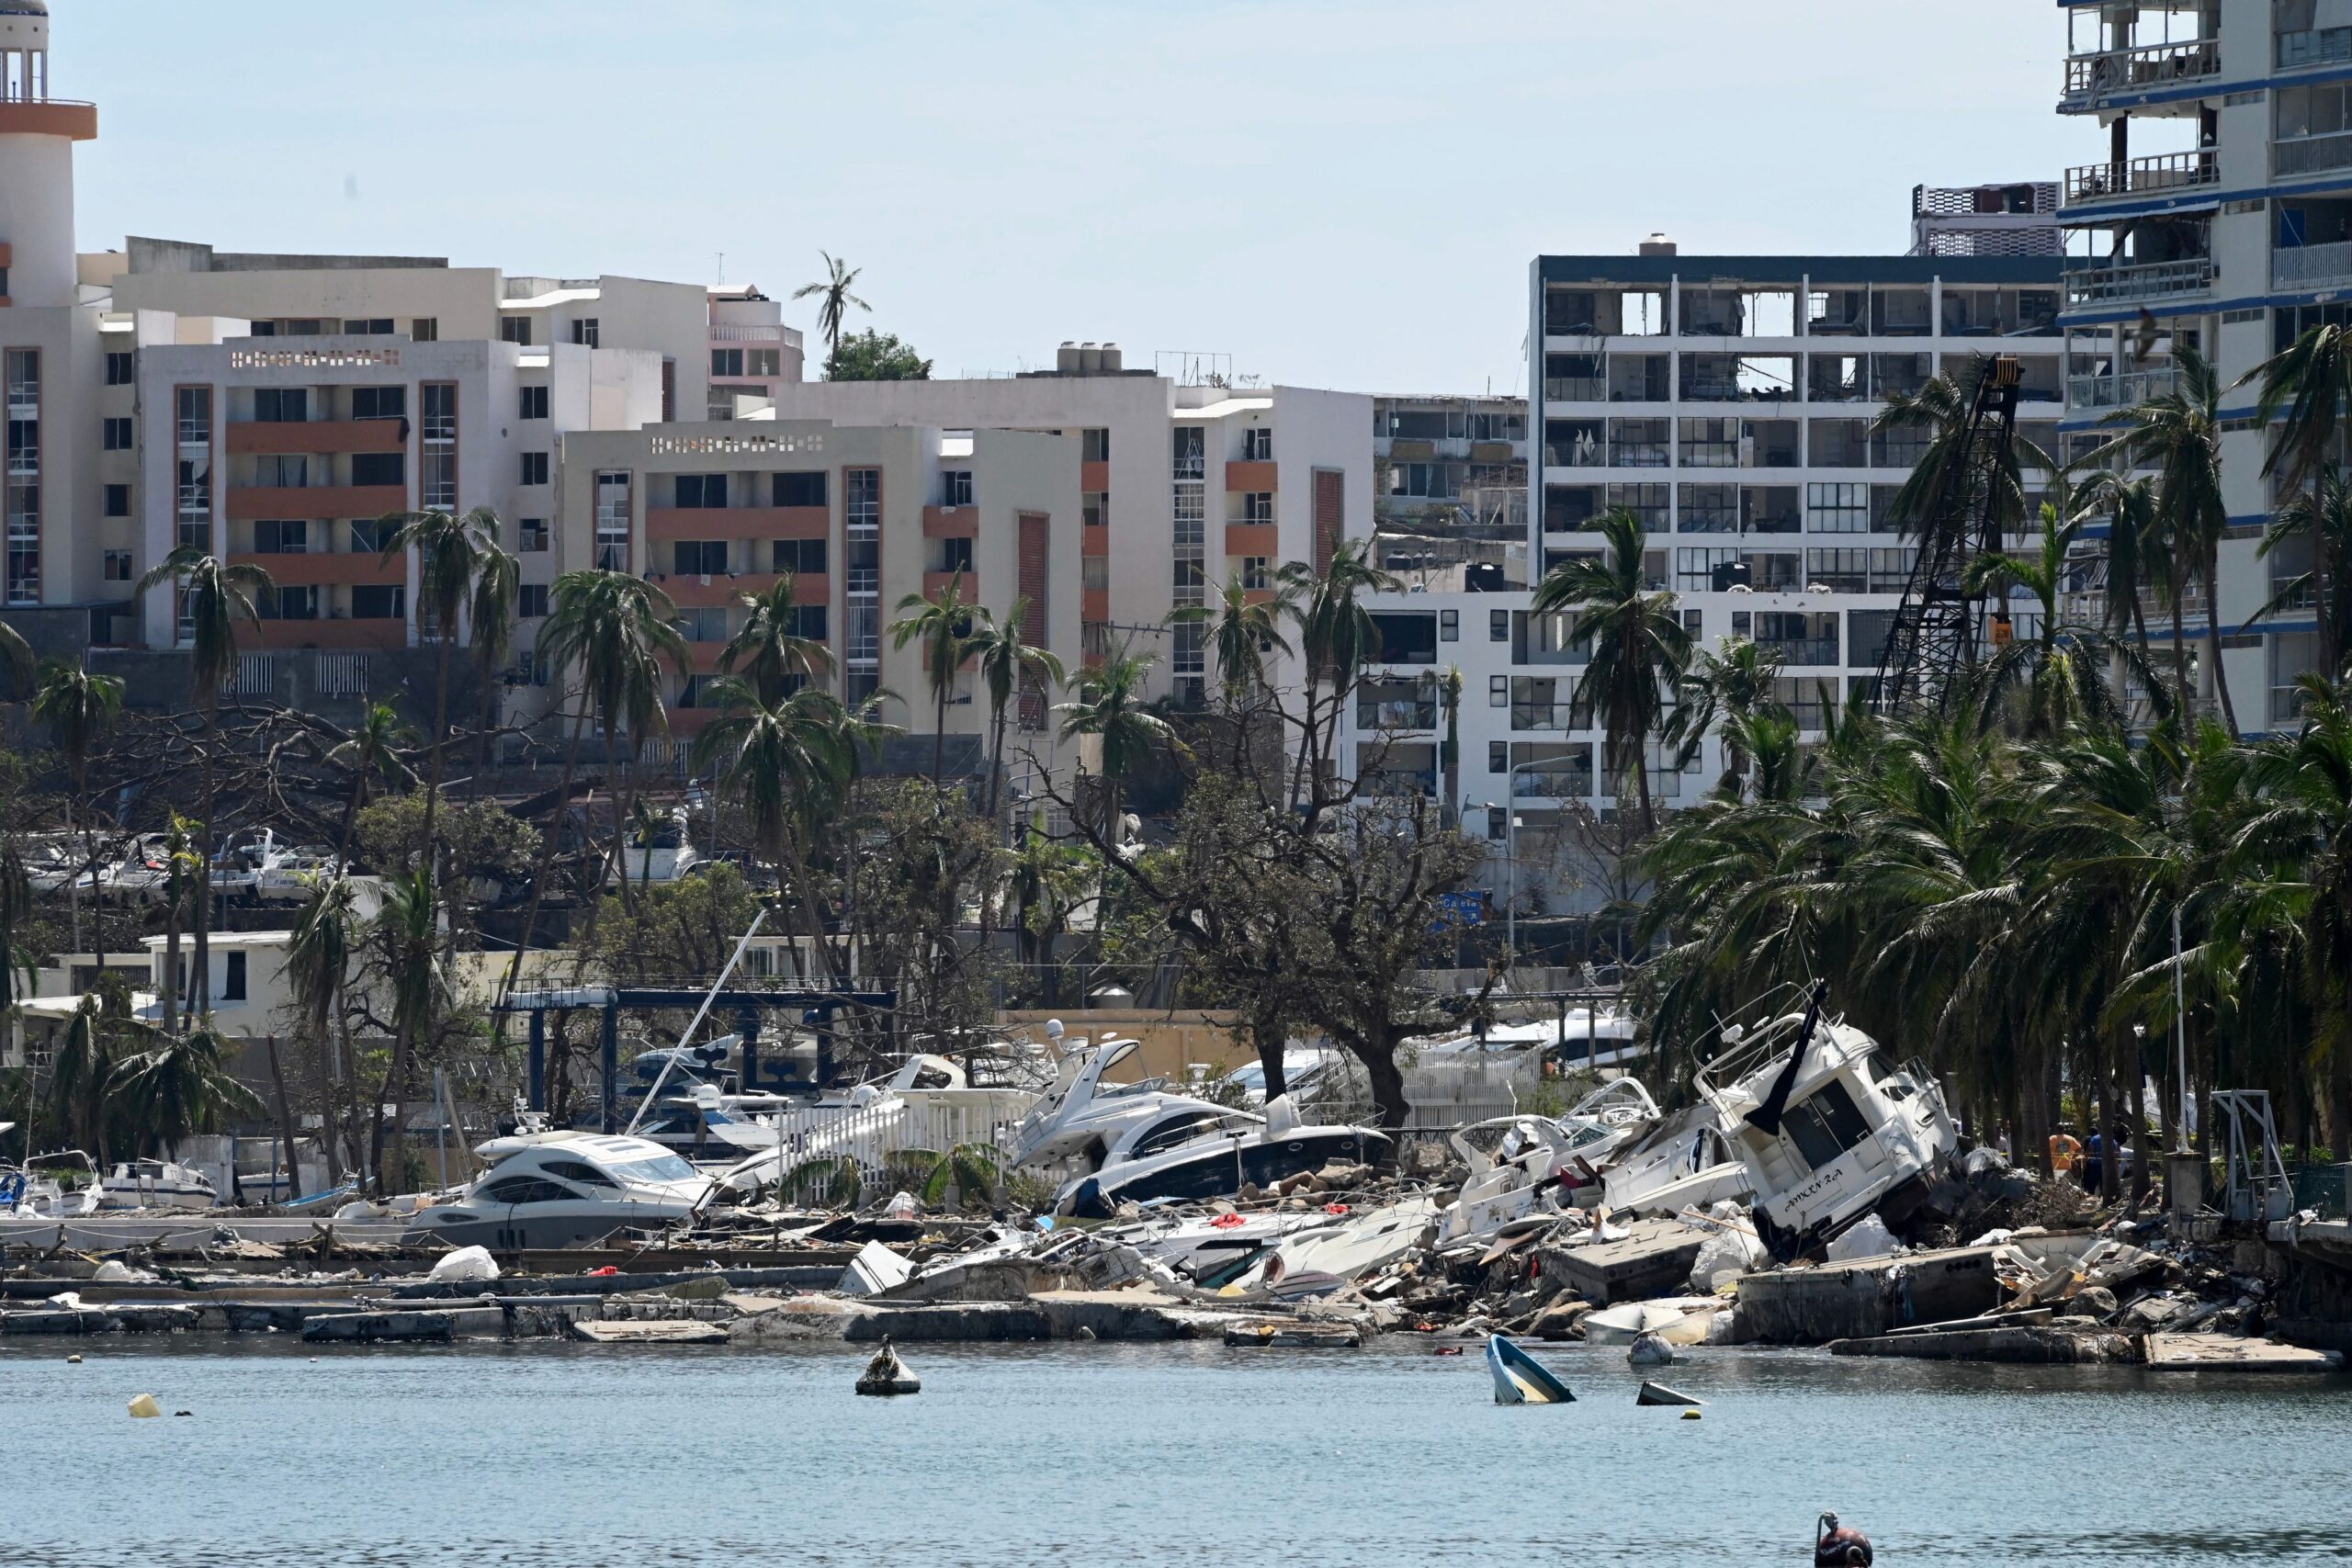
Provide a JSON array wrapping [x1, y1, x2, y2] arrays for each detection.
[[555, 416, 1084, 766]]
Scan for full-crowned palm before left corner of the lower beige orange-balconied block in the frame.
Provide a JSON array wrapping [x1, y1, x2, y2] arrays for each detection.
[[545, 569, 694, 912]]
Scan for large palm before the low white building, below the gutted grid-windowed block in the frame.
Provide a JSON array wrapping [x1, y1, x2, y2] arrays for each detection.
[[1529, 508, 1691, 829]]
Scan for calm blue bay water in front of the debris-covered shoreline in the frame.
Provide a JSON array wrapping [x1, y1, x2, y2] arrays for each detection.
[[0, 1337, 2352, 1568]]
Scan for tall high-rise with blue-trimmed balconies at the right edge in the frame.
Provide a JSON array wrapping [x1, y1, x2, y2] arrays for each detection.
[[2058, 0, 2352, 733]]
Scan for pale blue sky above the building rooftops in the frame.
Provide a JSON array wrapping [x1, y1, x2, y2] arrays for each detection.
[[68, 0, 2103, 392]]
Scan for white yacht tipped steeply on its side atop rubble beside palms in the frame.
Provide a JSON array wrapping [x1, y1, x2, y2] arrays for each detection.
[[1691, 987, 1959, 1262]]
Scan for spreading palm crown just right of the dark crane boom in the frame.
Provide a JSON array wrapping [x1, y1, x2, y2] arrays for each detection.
[[1959, 505, 2154, 740]]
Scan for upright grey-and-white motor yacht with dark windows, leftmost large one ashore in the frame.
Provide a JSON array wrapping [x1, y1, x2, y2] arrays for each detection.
[[409, 1134, 710, 1251]]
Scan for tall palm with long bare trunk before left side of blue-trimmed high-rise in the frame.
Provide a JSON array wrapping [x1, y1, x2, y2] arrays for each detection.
[[2108, 344, 2239, 736]]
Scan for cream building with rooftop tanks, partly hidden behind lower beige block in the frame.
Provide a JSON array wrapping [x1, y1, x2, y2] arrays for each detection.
[[752, 345, 1374, 703]]
